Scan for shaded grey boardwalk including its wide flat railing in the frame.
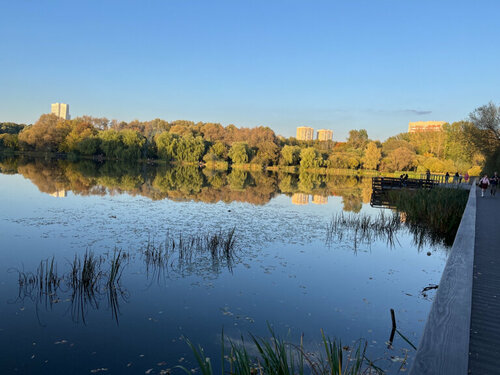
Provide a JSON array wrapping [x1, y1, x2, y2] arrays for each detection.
[[410, 185, 500, 375]]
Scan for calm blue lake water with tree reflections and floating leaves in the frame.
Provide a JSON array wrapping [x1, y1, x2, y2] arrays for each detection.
[[0, 159, 447, 374]]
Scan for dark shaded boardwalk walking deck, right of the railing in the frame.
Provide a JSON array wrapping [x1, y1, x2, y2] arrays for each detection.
[[469, 189, 500, 375]]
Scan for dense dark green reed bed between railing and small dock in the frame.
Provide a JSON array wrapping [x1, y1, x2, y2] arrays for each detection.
[[388, 187, 469, 246]]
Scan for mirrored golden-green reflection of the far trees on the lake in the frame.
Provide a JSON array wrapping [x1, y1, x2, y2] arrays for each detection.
[[0, 157, 371, 212]]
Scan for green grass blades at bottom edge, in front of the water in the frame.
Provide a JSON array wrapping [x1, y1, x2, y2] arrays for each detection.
[[178, 327, 384, 375]]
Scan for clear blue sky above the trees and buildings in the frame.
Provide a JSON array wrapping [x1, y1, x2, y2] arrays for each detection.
[[0, 0, 500, 141]]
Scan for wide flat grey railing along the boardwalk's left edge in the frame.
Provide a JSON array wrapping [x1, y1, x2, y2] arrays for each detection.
[[410, 183, 476, 375]]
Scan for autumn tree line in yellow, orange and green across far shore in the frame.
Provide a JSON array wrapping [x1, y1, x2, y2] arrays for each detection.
[[0, 103, 500, 175]]
